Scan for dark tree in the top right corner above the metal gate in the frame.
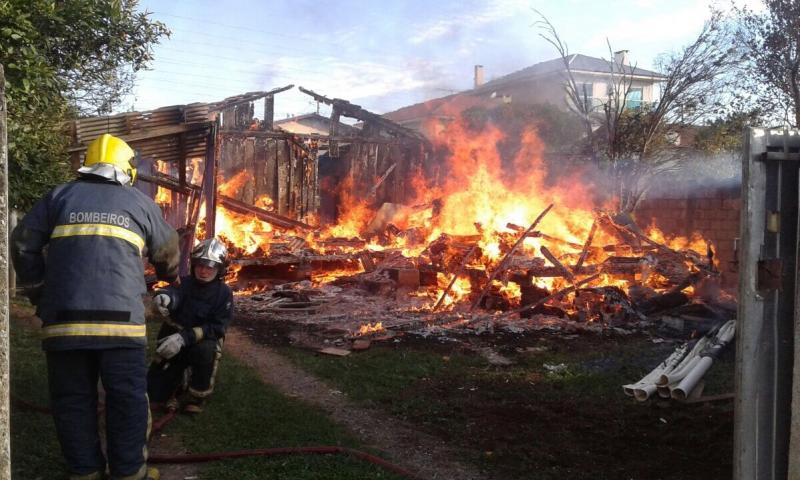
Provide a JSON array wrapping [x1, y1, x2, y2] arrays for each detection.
[[734, 0, 800, 127]]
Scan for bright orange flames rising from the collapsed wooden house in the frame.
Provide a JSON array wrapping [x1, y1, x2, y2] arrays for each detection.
[[198, 114, 708, 309]]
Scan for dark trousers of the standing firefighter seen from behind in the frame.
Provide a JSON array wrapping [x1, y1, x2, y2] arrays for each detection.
[[47, 348, 150, 480]]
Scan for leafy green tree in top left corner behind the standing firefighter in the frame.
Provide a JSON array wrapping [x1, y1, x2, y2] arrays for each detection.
[[0, 0, 169, 209]]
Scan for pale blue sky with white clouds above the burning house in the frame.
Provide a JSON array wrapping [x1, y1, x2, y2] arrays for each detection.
[[126, 0, 756, 120]]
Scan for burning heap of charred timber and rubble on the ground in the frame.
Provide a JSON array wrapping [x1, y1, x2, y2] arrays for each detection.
[[228, 201, 736, 344]]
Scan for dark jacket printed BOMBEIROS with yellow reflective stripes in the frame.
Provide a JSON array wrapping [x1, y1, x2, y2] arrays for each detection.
[[11, 176, 178, 350]]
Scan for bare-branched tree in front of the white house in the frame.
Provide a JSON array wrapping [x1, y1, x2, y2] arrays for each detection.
[[537, 12, 737, 212]]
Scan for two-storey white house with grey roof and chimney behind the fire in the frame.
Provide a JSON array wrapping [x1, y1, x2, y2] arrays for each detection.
[[383, 50, 665, 138]]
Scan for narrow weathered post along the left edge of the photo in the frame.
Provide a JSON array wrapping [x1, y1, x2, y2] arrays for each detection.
[[0, 64, 11, 480]]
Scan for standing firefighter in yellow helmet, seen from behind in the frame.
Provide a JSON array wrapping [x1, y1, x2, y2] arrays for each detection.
[[11, 134, 178, 480]]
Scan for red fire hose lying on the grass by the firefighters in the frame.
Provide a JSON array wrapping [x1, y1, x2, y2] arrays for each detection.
[[12, 397, 420, 480]]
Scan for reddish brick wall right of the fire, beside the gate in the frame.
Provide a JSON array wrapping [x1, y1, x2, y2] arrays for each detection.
[[635, 185, 741, 286]]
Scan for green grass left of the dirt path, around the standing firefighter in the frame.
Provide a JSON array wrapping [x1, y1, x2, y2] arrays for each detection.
[[11, 305, 400, 480]]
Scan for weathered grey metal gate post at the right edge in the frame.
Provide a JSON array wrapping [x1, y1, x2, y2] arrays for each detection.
[[733, 128, 800, 480]]
